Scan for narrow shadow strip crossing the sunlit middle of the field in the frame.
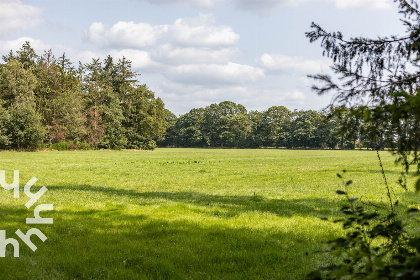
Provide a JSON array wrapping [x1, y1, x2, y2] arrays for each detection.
[[48, 185, 339, 218]]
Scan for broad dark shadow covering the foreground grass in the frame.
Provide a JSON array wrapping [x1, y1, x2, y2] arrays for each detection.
[[0, 201, 336, 280]]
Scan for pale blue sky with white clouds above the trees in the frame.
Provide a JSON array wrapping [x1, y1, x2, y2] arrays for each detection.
[[0, 0, 405, 116]]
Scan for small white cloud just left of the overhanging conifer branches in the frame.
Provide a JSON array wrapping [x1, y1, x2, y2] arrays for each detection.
[[259, 53, 330, 74]]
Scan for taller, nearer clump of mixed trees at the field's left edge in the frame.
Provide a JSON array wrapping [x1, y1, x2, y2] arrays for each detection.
[[0, 42, 168, 149]]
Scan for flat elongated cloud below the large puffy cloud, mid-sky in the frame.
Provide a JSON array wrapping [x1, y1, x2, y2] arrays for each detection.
[[164, 62, 264, 87]]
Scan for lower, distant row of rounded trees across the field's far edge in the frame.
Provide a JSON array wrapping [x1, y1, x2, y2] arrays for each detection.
[[158, 101, 391, 149]]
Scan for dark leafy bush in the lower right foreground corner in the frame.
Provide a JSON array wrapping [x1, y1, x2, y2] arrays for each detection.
[[308, 167, 420, 279]]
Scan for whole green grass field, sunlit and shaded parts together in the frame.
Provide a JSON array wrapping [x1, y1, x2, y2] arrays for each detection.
[[0, 149, 420, 279]]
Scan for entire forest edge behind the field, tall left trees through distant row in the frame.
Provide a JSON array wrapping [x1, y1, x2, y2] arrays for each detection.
[[0, 42, 387, 150]]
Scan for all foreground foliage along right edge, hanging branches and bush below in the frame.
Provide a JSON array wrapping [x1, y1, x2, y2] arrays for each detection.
[[306, 0, 420, 279]]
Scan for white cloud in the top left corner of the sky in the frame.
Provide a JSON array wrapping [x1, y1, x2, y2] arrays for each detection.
[[0, 0, 42, 36]]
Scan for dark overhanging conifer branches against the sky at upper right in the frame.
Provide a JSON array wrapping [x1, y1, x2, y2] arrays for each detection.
[[306, 0, 420, 174]]
